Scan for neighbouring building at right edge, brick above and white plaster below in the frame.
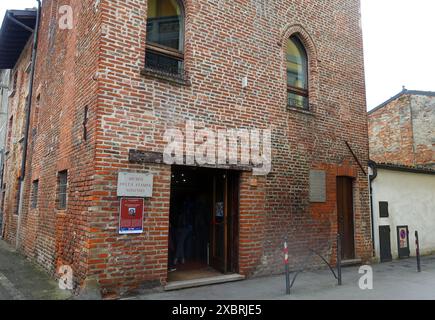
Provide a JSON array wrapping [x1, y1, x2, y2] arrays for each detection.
[[369, 89, 435, 261]]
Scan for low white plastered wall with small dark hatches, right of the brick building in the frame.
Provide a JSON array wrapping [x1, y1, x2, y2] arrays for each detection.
[[372, 164, 435, 262]]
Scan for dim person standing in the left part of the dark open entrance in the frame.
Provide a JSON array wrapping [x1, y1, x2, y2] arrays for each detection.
[[174, 197, 194, 265]]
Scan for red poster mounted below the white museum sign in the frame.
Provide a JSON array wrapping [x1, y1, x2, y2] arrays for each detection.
[[119, 198, 145, 234]]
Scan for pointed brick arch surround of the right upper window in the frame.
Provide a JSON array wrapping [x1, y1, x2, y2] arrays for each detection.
[[281, 24, 319, 113]]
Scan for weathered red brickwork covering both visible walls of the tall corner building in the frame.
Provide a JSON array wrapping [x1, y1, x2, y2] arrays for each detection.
[[1, 0, 372, 293]]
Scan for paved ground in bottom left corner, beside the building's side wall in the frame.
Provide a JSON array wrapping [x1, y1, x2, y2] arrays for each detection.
[[0, 240, 71, 300]]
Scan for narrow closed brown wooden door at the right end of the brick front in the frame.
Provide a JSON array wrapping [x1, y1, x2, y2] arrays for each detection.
[[337, 177, 355, 260]]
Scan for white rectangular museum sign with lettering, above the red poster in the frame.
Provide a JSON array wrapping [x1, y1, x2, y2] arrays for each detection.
[[117, 172, 153, 198]]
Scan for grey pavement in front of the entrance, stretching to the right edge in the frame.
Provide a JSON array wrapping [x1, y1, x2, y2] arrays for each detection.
[[136, 256, 435, 300]]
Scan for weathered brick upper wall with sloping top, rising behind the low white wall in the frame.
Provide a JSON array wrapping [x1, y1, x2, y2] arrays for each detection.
[[369, 89, 435, 169]]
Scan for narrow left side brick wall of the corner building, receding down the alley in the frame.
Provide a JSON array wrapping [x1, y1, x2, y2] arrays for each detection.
[[2, 0, 100, 284]]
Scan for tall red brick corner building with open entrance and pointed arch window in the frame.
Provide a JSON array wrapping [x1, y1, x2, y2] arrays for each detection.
[[0, 0, 372, 293]]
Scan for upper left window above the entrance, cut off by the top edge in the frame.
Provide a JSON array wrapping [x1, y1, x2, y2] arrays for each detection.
[[146, 0, 184, 75]]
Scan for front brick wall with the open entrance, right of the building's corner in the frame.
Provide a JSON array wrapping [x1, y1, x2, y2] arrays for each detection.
[[91, 0, 371, 292]]
